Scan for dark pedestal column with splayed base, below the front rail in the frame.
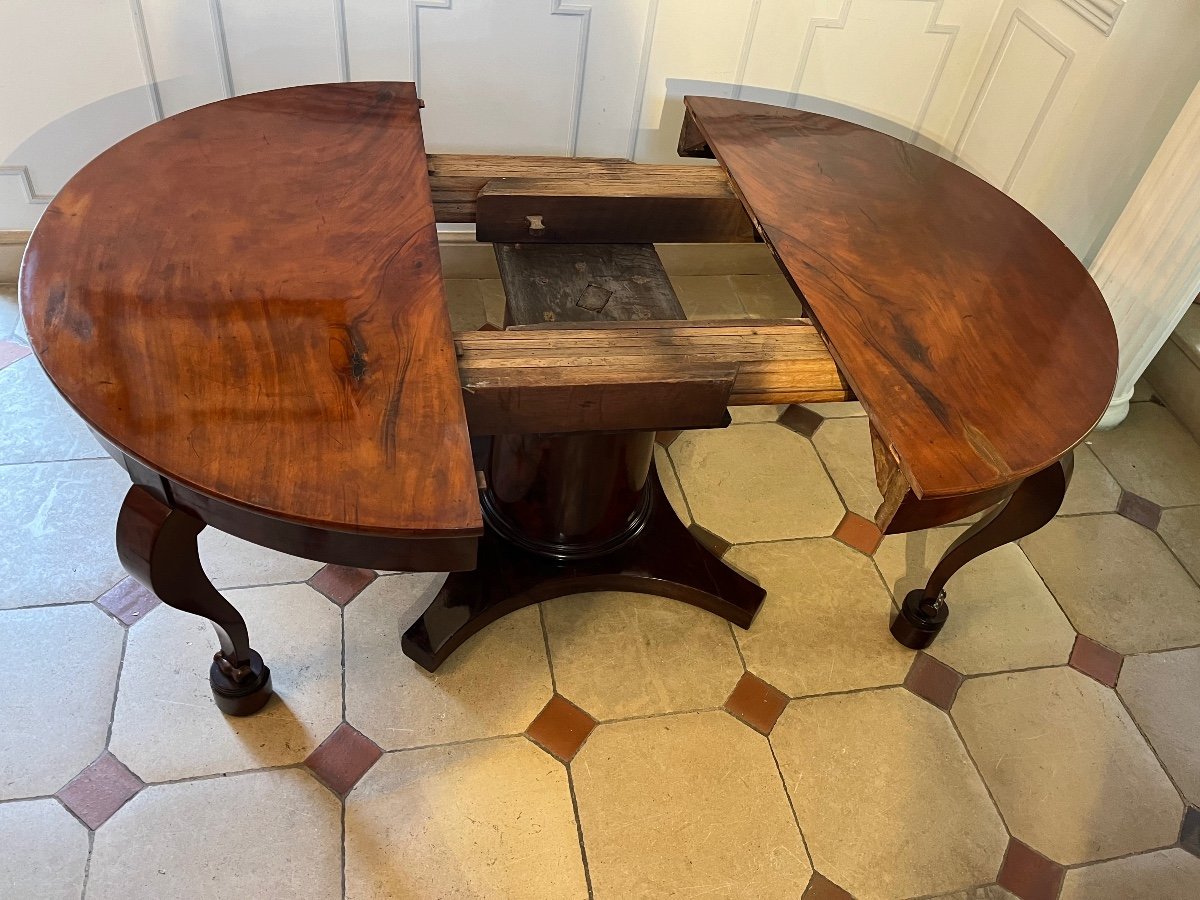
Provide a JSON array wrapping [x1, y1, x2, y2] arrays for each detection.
[[401, 433, 766, 672]]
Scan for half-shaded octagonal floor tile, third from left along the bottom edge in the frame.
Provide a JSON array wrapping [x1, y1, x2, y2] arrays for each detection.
[[346, 738, 588, 900]]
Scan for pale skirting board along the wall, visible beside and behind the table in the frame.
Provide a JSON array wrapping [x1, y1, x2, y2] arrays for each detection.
[[0, 230, 779, 284]]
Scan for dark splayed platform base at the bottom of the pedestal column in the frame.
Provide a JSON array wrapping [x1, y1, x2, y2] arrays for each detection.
[[401, 472, 766, 672]]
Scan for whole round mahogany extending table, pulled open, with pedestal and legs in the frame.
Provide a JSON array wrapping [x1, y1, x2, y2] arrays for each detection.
[[20, 83, 1117, 714]]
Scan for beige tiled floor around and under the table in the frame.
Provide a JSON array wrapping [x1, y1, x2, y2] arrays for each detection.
[[7, 276, 1200, 900]]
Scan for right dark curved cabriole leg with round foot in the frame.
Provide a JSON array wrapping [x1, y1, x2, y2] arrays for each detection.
[[892, 451, 1074, 650]]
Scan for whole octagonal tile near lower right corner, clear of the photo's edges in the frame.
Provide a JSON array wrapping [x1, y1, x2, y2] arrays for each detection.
[[952, 668, 1183, 865]]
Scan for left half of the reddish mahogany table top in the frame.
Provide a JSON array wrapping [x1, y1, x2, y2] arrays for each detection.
[[20, 83, 482, 568]]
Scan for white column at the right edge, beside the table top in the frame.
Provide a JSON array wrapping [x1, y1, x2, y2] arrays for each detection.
[[1091, 79, 1200, 428]]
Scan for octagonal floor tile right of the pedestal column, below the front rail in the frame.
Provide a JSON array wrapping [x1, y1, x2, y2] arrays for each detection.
[[668, 424, 845, 544]]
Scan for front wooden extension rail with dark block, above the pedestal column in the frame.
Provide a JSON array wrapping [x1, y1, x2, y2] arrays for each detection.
[[455, 319, 853, 434]]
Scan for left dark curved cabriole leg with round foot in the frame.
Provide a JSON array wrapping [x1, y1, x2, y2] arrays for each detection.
[[116, 485, 271, 715]]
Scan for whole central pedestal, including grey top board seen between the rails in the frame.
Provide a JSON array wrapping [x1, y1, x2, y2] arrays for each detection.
[[401, 244, 766, 671]]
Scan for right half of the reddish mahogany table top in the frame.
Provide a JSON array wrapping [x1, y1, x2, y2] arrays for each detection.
[[684, 97, 1117, 508]]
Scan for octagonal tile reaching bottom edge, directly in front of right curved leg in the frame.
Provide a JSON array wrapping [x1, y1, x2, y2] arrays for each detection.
[[770, 689, 1008, 900]]
